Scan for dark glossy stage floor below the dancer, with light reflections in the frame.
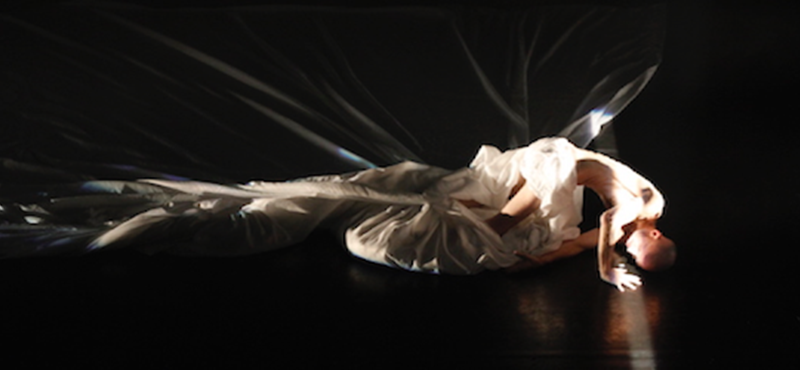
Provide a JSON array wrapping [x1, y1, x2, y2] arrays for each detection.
[[0, 220, 800, 369]]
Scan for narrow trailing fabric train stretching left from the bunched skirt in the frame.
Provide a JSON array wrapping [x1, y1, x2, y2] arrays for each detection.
[[0, 162, 441, 257]]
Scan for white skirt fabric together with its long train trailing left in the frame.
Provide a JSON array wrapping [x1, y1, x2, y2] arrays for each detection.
[[0, 138, 582, 274]]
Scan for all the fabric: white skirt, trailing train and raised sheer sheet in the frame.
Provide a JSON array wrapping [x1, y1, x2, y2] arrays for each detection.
[[0, 4, 663, 268]]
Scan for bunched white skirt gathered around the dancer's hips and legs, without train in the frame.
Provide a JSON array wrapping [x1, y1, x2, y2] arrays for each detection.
[[338, 138, 583, 274]]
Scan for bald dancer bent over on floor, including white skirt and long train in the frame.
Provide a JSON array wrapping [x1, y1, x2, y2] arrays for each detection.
[[0, 138, 675, 290]]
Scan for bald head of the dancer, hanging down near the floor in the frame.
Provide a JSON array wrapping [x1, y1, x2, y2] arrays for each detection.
[[625, 226, 677, 271]]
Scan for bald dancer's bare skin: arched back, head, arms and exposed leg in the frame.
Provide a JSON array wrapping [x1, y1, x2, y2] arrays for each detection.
[[500, 139, 676, 290]]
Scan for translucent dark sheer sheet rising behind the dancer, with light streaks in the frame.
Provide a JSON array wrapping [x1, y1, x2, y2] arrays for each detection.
[[0, 4, 664, 182]]
